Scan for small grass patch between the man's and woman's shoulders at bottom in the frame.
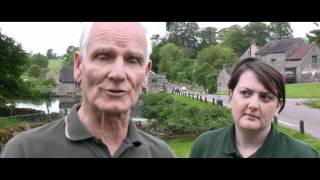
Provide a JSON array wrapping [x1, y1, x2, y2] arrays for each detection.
[[164, 137, 195, 158]]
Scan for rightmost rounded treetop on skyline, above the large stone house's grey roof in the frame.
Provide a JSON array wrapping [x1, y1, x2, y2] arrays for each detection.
[[269, 22, 293, 40]]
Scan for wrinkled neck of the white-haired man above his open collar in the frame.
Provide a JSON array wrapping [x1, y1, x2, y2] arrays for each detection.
[[78, 105, 130, 156]]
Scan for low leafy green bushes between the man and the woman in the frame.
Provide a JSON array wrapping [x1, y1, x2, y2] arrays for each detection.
[[142, 92, 232, 134]]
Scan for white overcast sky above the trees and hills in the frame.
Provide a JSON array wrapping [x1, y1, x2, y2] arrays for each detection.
[[0, 22, 320, 55]]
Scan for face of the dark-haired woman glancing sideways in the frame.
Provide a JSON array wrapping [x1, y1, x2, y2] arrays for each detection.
[[229, 70, 281, 131]]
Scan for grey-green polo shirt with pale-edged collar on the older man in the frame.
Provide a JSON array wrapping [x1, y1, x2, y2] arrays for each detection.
[[2, 104, 175, 158]]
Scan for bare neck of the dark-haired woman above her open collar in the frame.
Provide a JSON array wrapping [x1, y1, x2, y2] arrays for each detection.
[[235, 126, 271, 158]]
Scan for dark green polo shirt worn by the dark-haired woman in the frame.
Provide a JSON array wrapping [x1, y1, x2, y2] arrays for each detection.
[[190, 124, 319, 158]]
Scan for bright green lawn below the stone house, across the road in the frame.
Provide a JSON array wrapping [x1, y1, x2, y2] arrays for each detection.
[[286, 83, 320, 98]]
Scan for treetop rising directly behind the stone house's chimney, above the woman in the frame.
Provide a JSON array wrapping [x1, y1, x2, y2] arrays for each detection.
[[243, 22, 270, 46]]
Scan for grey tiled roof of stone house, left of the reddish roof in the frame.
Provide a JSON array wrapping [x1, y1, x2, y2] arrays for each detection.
[[256, 38, 301, 55]]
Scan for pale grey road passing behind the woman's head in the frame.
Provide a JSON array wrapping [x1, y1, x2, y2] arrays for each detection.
[[204, 94, 320, 138]]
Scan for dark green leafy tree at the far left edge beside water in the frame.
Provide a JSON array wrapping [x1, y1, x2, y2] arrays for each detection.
[[0, 31, 29, 99]]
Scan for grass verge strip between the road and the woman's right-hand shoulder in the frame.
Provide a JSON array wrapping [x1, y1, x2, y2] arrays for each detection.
[[278, 126, 320, 153]]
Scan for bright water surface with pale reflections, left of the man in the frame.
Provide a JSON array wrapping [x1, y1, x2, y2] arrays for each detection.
[[12, 97, 79, 114]]
